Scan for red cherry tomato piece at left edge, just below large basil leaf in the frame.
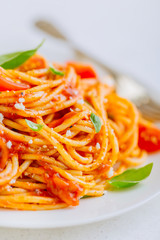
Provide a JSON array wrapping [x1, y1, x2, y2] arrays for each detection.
[[0, 67, 30, 91]]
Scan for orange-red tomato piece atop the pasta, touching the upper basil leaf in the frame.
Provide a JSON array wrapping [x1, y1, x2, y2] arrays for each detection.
[[18, 54, 47, 72]]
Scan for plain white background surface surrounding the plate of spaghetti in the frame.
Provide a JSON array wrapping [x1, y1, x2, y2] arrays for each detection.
[[0, 0, 160, 240]]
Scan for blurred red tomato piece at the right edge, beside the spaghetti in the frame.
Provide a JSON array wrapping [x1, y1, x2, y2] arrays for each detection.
[[138, 124, 160, 153]]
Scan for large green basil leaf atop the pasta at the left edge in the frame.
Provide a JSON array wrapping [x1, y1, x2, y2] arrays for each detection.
[[0, 40, 44, 69]]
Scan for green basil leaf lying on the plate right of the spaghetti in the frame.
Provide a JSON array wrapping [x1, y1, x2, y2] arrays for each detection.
[[108, 163, 153, 188]]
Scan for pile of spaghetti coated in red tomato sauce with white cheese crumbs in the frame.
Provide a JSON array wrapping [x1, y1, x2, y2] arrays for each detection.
[[0, 55, 159, 210]]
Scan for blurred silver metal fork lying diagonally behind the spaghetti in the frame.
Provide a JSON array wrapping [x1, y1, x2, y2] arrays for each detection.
[[35, 20, 160, 121]]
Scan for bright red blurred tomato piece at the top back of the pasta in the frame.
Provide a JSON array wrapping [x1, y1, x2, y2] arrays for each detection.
[[67, 62, 97, 78]]
